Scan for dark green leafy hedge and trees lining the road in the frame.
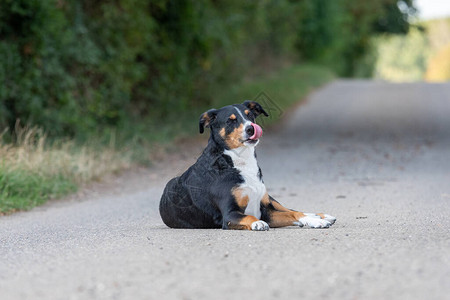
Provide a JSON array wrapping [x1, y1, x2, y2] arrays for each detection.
[[0, 0, 411, 140]]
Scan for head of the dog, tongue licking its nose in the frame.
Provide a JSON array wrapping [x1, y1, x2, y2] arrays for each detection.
[[199, 101, 269, 149]]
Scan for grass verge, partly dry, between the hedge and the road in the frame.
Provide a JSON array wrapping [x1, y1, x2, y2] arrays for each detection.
[[0, 65, 334, 214]]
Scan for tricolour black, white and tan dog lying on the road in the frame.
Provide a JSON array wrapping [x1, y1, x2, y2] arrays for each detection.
[[159, 101, 336, 231]]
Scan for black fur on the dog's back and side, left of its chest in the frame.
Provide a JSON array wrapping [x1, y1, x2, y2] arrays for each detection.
[[160, 136, 243, 228]]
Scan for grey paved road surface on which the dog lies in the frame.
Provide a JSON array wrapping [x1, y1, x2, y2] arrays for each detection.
[[0, 80, 450, 300]]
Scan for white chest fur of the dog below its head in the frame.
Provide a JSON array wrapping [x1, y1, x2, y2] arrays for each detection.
[[224, 147, 266, 219]]
